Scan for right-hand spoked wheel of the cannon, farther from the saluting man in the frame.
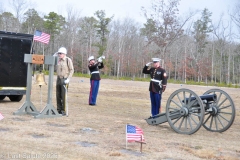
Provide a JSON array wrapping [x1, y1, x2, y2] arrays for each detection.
[[203, 89, 235, 132]]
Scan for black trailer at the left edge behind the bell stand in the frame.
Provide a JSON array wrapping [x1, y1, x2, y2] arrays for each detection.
[[0, 31, 33, 102]]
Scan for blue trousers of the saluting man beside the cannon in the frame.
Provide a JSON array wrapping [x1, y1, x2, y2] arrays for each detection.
[[150, 92, 162, 117]]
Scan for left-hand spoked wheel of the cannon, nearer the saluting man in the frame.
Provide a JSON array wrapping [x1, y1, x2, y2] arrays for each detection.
[[166, 88, 205, 134]]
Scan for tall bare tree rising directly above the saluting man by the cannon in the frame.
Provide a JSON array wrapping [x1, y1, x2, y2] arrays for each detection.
[[142, 0, 195, 57]]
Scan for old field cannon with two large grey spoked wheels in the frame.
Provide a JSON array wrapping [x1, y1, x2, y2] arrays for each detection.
[[145, 88, 235, 135]]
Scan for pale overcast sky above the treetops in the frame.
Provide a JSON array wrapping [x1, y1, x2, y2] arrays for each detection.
[[0, 0, 238, 23]]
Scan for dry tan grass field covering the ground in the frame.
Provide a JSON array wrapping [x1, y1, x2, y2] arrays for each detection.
[[0, 77, 240, 160]]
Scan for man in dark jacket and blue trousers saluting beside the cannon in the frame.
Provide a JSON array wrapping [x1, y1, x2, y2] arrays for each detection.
[[143, 58, 167, 117]]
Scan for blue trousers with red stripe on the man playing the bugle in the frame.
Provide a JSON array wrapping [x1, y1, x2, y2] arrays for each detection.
[[88, 80, 100, 105]]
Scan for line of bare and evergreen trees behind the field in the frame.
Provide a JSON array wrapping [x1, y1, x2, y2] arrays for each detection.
[[0, 0, 240, 84]]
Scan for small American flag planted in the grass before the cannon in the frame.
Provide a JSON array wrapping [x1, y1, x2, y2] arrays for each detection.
[[126, 124, 144, 142]]
